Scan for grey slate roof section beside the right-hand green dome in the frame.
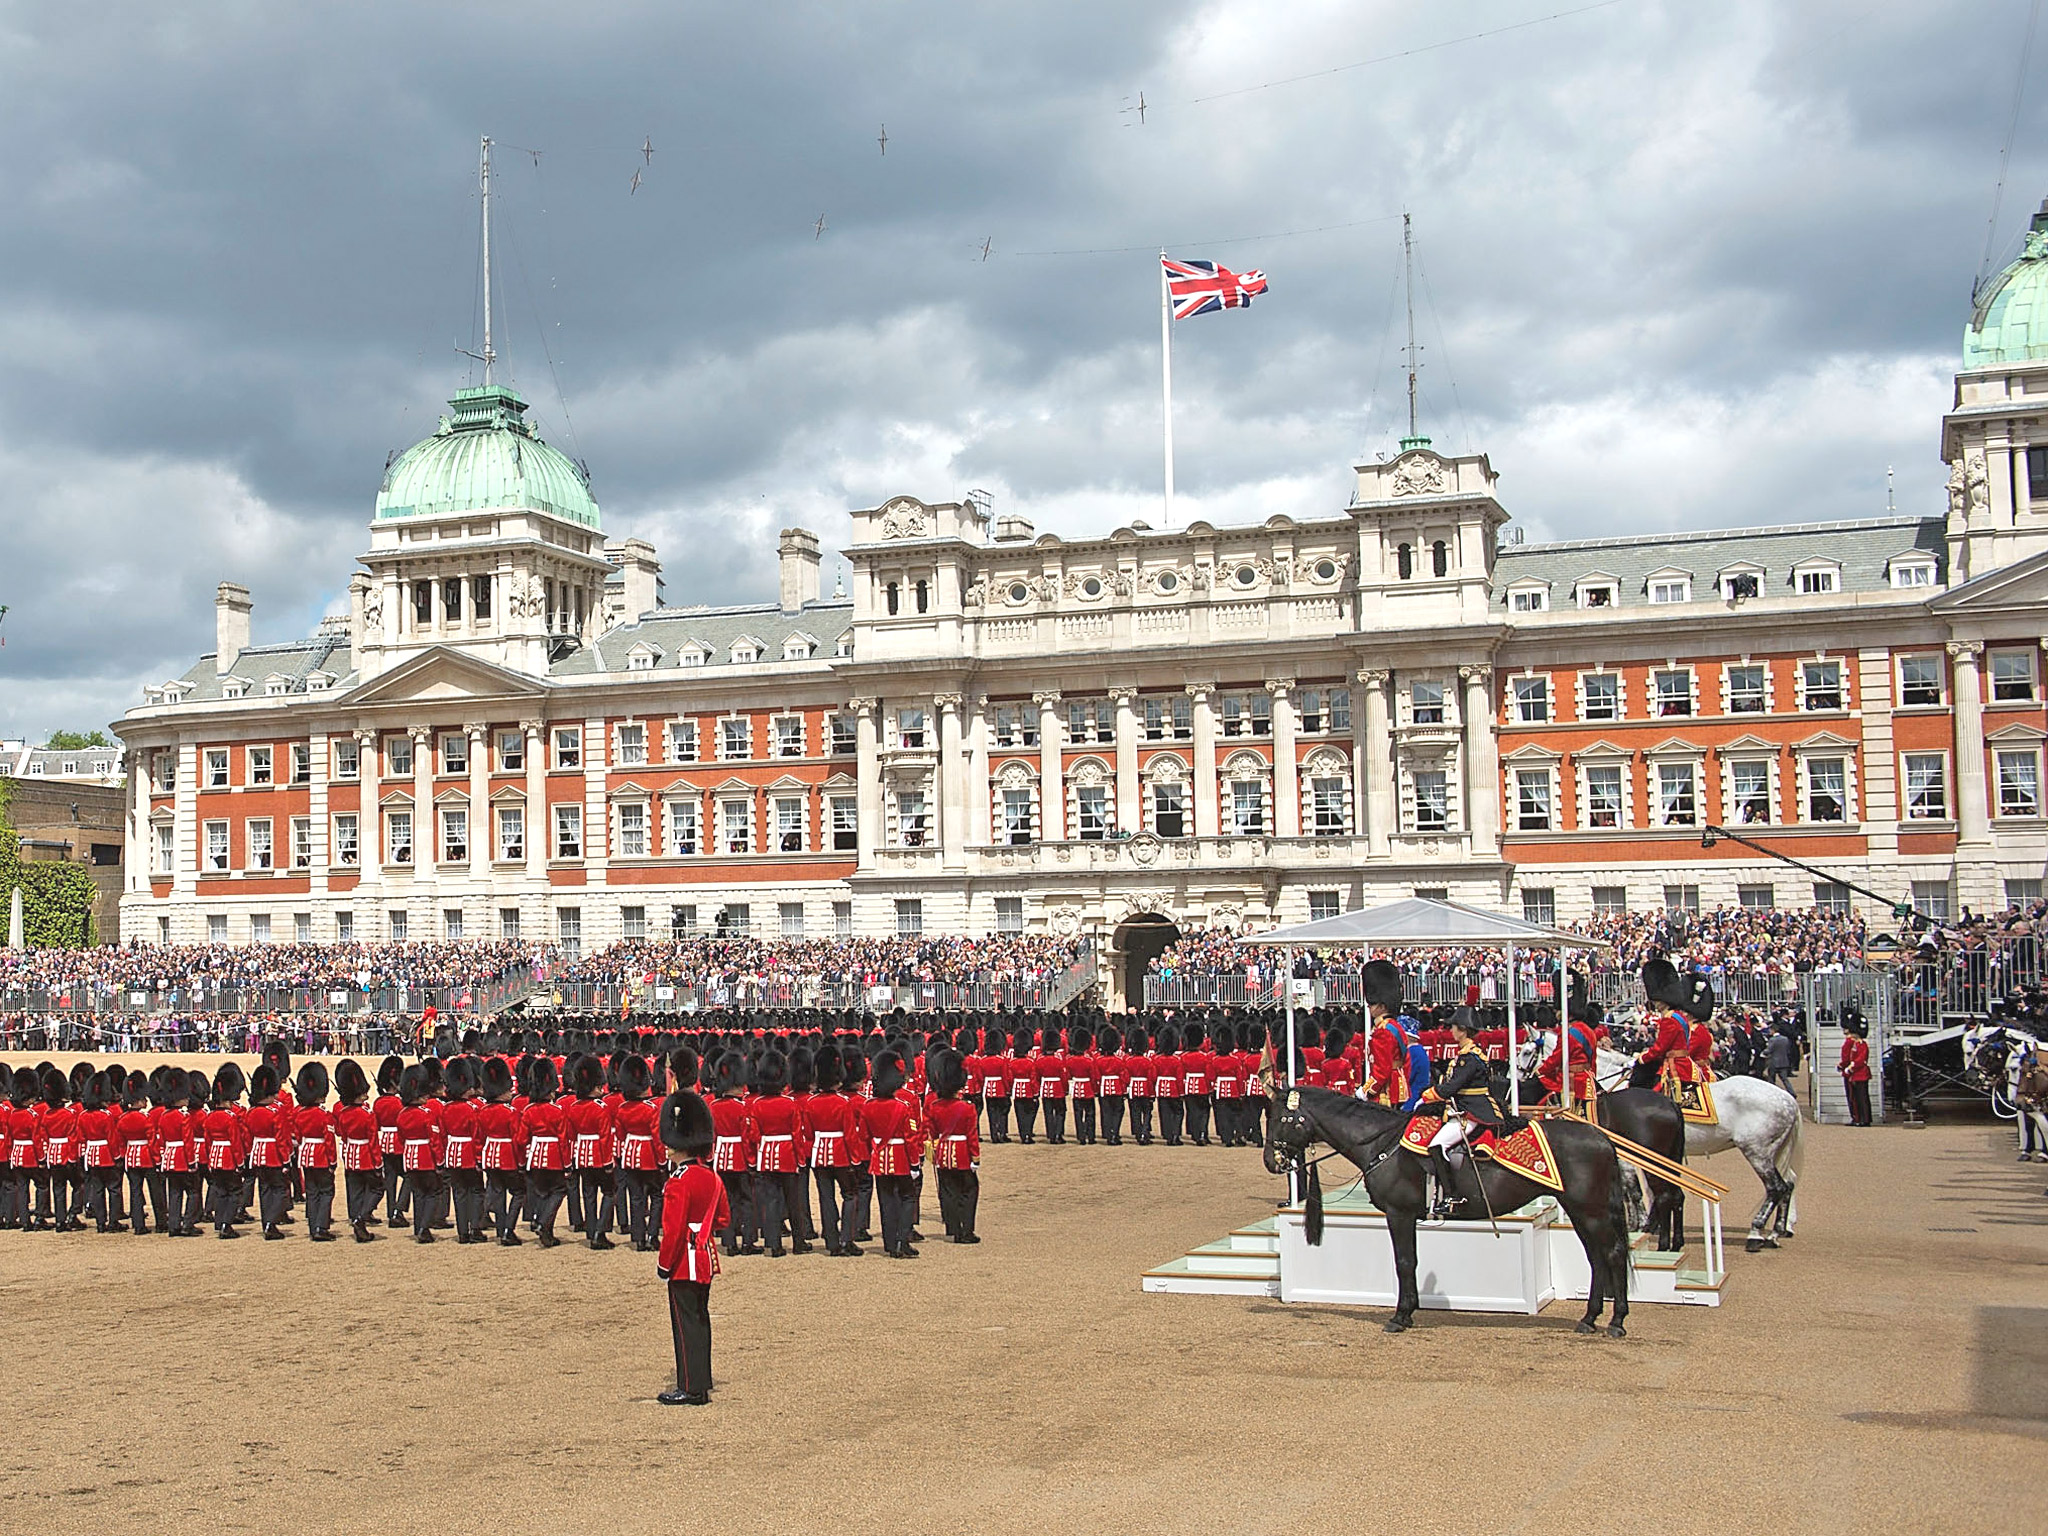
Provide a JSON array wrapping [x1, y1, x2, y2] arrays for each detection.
[[1491, 516, 1948, 610]]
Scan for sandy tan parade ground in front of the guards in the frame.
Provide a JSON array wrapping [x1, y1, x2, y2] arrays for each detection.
[[0, 1056, 2048, 1536]]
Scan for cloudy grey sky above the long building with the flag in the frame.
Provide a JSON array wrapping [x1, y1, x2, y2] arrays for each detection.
[[0, 0, 2048, 739]]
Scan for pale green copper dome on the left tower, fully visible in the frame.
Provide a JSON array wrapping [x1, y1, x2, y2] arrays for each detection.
[[377, 385, 598, 528]]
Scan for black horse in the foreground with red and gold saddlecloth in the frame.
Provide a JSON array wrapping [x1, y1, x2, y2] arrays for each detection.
[[1266, 1087, 1628, 1339]]
